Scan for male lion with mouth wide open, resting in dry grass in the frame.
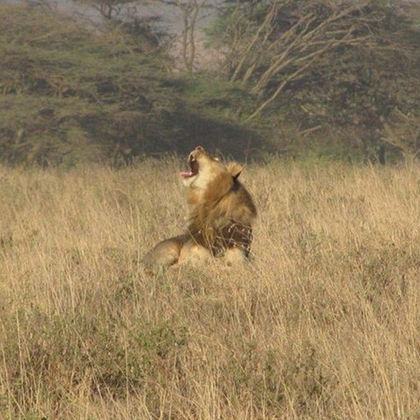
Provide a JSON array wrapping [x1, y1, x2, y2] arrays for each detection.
[[143, 146, 257, 268]]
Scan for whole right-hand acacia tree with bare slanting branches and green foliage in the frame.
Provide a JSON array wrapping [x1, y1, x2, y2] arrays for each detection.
[[211, 0, 420, 161]]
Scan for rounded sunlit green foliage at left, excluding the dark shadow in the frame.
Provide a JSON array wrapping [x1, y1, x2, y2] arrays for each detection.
[[0, 6, 177, 165]]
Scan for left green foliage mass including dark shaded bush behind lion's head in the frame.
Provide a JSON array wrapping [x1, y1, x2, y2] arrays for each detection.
[[0, 6, 268, 166]]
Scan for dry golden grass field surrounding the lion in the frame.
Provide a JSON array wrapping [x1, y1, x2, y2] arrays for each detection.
[[0, 160, 420, 420]]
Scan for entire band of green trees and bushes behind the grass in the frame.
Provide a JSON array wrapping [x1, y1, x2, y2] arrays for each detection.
[[0, 0, 420, 166]]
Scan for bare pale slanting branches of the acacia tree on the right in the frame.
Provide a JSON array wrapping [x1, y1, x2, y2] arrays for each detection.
[[215, 0, 382, 120]]
